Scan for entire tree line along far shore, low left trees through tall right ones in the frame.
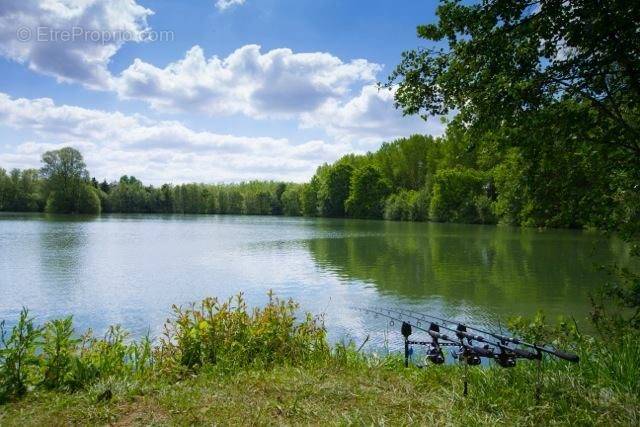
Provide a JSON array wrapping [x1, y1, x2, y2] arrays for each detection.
[[0, 127, 613, 232]]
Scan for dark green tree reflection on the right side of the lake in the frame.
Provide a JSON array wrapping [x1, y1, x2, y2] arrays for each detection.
[[307, 221, 629, 319]]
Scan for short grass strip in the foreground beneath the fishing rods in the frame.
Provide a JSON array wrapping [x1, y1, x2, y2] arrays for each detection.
[[0, 359, 640, 426]]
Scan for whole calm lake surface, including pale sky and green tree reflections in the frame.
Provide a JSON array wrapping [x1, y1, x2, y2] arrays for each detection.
[[0, 214, 628, 352]]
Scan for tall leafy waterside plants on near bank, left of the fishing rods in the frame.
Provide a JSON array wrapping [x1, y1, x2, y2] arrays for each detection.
[[0, 293, 330, 402]]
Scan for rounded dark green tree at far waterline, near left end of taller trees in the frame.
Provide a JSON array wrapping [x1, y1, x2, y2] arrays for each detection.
[[345, 165, 389, 219]]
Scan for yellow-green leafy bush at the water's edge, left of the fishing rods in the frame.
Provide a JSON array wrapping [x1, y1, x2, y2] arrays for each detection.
[[160, 293, 329, 370]]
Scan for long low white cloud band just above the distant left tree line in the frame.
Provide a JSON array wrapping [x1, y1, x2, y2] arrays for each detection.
[[0, 93, 352, 184]]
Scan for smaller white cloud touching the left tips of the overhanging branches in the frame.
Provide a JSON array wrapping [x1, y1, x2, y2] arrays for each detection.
[[301, 85, 444, 149]]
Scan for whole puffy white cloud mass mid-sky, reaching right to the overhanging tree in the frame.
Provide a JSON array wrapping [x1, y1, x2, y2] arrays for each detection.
[[118, 45, 444, 145]]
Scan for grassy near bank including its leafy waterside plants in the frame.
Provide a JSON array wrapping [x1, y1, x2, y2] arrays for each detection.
[[0, 294, 640, 426]]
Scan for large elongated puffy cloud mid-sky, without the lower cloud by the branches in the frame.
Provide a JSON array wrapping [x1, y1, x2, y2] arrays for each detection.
[[117, 45, 380, 118]]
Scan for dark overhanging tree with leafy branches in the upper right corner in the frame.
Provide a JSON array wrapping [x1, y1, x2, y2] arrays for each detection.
[[388, 0, 640, 229]]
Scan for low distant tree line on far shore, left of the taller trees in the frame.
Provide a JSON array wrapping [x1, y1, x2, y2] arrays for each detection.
[[0, 147, 300, 215]]
